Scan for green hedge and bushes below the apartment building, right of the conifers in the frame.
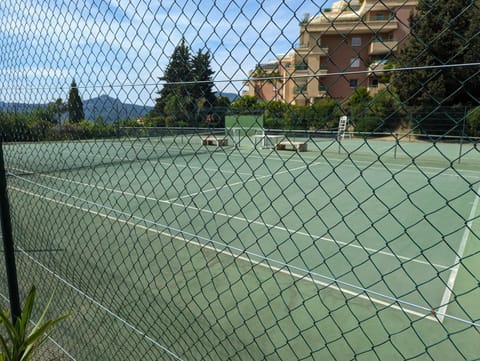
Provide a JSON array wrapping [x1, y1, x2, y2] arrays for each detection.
[[229, 87, 480, 137]]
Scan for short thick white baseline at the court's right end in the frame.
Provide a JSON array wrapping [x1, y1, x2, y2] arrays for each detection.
[[438, 186, 480, 322]]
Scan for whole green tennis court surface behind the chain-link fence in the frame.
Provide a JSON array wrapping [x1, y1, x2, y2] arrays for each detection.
[[5, 138, 480, 360]]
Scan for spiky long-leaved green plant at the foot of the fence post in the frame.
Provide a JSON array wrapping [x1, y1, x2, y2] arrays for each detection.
[[0, 287, 69, 361]]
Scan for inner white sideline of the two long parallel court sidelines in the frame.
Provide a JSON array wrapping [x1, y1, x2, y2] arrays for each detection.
[[9, 169, 449, 269]]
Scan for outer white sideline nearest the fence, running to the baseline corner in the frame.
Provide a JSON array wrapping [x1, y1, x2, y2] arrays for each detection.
[[11, 187, 437, 320]]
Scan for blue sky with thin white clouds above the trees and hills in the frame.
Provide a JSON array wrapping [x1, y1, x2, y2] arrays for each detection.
[[0, 0, 332, 105]]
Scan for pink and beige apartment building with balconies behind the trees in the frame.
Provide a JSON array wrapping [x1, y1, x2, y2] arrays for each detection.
[[246, 0, 417, 105]]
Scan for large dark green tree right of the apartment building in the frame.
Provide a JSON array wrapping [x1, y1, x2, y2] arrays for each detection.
[[392, 0, 480, 109]]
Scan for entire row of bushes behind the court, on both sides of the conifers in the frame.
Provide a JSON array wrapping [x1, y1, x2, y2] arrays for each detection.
[[0, 88, 480, 142]]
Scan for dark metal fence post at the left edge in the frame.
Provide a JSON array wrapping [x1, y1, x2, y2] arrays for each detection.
[[0, 139, 22, 323]]
